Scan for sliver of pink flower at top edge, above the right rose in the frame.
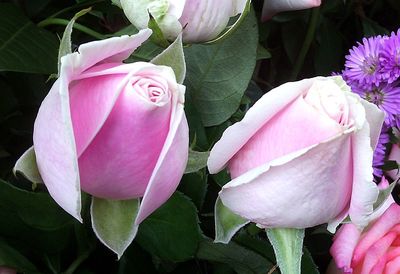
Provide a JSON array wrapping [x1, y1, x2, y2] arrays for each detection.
[[261, 0, 321, 21]]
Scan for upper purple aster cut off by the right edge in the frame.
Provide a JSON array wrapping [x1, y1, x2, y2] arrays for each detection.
[[379, 29, 400, 83]]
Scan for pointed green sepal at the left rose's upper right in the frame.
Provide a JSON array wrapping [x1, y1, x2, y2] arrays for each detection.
[[151, 35, 186, 84]]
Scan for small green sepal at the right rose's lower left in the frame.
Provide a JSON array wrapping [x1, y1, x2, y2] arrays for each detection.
[[214, 197, 249, 244]]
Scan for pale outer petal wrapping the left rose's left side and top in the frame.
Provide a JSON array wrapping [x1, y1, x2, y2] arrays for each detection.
[[33, 30, 151, 221]]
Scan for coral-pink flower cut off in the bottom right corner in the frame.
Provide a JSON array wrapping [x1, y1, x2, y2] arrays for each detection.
[[328, 179, 400, 274]]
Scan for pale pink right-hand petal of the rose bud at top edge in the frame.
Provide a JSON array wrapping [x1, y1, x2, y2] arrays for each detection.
[[179, 0, 239, 43]]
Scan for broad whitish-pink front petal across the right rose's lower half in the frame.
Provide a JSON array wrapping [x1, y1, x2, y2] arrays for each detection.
[[220, 133, 352, 228]]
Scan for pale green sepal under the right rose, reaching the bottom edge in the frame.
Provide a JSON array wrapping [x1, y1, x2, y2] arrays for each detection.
[[266, 228, 304, 274]]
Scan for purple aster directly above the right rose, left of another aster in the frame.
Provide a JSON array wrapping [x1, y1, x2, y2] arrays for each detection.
[[343, 36, 382, 89]]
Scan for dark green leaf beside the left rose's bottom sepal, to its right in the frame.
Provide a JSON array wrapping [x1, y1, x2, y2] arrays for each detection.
[[136, 192, 201, 262]]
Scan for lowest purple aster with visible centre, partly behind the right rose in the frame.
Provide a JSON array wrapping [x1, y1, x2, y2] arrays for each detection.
[[351, 83, 400, 126]]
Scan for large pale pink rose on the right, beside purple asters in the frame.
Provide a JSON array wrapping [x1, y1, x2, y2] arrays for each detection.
[[208, 77, 383, 231]]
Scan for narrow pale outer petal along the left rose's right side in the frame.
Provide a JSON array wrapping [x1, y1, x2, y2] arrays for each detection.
[[135, 86, 189, 225]]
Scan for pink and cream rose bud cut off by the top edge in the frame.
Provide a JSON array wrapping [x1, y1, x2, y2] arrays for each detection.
[[120, 0, 246, 43]]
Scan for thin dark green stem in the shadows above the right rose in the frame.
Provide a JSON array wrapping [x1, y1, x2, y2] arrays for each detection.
[[290, 7, 319, 80]]
